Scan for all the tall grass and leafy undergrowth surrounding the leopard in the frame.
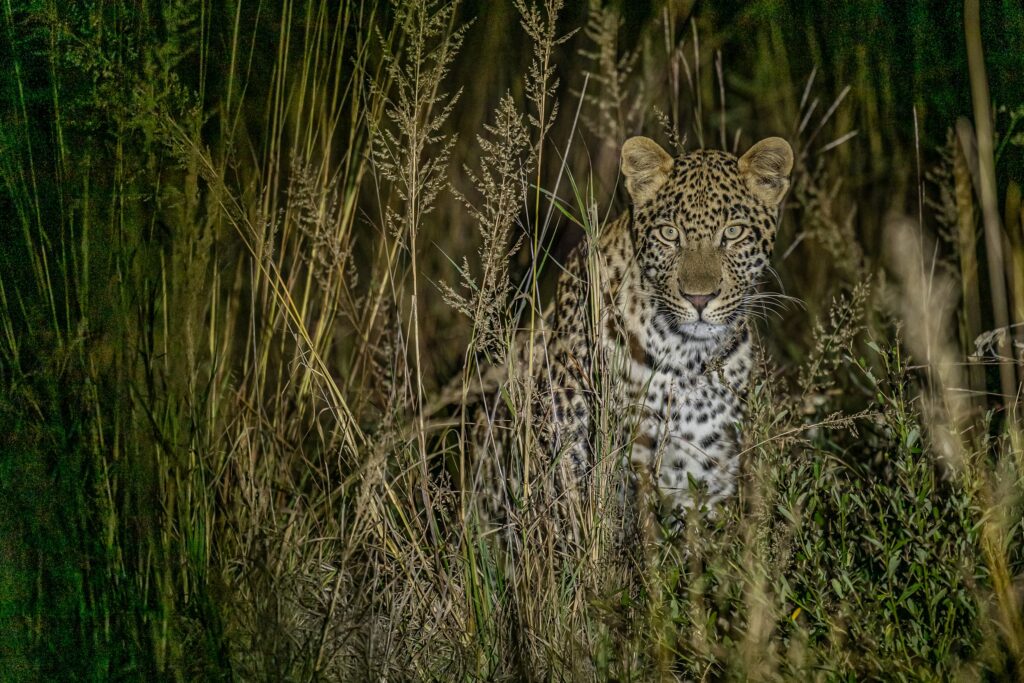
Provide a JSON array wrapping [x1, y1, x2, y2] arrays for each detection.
[[0, 0, 1024, 681]]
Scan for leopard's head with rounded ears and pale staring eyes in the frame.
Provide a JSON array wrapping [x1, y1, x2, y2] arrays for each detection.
[[622, 137, 793, 340]]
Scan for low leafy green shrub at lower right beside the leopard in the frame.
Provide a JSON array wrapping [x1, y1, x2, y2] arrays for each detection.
[[773, 335, 981, 679]]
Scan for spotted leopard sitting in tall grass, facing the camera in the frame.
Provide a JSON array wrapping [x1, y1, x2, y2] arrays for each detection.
[[473, 136, 794, 536]]
